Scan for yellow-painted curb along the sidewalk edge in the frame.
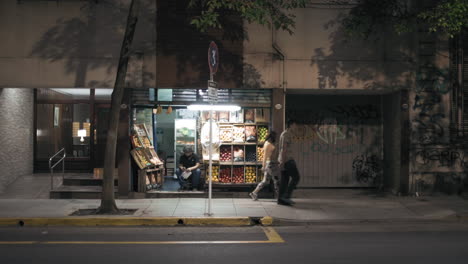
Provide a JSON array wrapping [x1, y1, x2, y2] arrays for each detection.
[[0, 217, 266, 227]]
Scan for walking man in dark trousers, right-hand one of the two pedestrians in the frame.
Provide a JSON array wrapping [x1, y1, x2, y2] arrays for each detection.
[[278, 119, 300, 206]]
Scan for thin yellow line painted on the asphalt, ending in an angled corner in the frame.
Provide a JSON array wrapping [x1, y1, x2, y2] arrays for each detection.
[[0, 227, 284, 245]]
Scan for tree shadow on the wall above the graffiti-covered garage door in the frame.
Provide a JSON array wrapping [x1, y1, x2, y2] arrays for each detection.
[[311, 14, 415, 92]]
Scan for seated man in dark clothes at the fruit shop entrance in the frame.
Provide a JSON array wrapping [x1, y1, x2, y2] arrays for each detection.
[[176, 147, 201, 190]]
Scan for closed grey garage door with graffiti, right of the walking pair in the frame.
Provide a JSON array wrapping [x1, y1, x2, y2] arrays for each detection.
[[286, 102, 382, 187]]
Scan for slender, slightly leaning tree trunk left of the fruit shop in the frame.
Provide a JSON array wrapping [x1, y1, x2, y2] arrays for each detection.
[[98, 0, 140, 214]]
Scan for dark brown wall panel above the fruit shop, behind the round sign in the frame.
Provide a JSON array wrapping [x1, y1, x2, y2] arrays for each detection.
[[157, 0, 246, 88]]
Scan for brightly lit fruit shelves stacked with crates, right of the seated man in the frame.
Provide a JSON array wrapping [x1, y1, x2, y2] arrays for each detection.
[[201, 109, 269, 188]]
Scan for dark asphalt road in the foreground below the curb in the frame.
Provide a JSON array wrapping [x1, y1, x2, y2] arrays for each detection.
[[0, 223, 468, 264]]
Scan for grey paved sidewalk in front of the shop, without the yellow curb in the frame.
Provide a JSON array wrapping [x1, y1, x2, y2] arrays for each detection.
[[0, 189, 468, 225]]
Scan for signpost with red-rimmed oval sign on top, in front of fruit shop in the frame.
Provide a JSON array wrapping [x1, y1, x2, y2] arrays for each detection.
[[206, 41, 219, 216]]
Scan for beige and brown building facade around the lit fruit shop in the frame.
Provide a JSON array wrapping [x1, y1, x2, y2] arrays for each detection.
[[0, 0, 467, 195]]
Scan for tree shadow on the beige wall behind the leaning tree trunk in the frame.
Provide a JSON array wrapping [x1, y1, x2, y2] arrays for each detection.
[[30, 0, 155, 87]]
